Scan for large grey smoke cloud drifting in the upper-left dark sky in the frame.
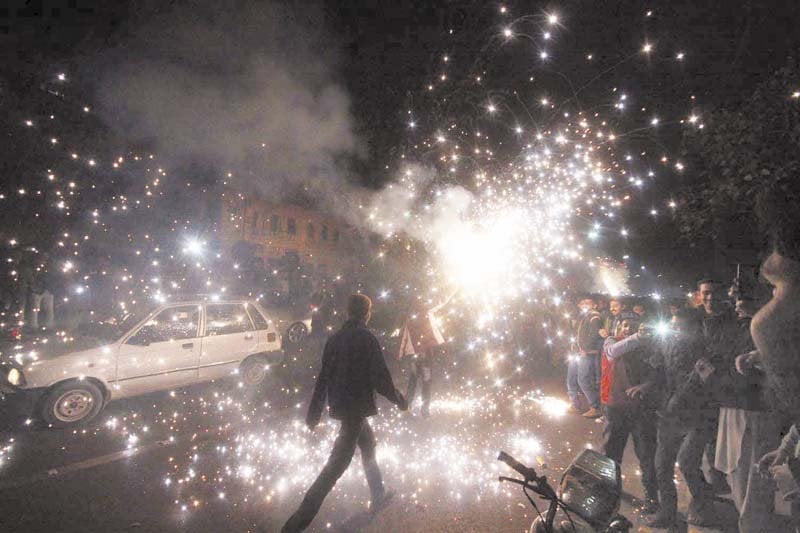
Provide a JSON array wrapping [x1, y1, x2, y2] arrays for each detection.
[[91, 1, 359, 194]]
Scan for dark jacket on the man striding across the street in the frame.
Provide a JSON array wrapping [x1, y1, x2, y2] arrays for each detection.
[[308, 320, 404, 420]]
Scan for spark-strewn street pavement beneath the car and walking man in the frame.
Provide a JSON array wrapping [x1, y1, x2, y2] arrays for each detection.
[[0, 342, 768, 533]]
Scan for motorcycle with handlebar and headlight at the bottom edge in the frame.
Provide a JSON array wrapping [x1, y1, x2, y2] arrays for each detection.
[[497, 449, 633, 533]]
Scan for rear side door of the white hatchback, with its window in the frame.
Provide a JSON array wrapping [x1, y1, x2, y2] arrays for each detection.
[[200, 302, 258, 381]]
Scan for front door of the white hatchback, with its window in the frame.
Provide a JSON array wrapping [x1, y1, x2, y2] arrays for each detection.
[[115, 304, 202, 396]]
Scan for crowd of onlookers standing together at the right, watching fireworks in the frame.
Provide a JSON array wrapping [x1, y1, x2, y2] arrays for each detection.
[[567, 274, 800, 533]]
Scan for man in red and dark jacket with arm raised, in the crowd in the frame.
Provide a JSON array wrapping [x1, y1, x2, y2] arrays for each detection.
[[600, 319, 658, 514]]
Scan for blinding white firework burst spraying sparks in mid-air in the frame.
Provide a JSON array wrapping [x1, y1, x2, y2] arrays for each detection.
[[364, 8, 698, 318]]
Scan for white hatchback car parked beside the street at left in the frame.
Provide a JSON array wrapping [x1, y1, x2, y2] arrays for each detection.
[[0, 300, 283, 427]]
